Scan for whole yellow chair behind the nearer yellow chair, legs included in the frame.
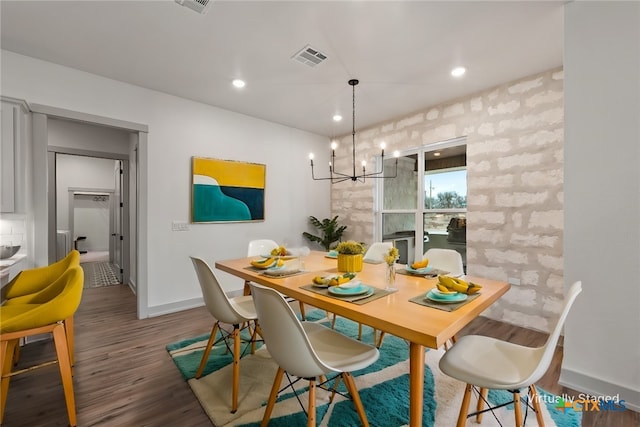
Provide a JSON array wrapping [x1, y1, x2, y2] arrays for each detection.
[[4, 249, 80, 366]]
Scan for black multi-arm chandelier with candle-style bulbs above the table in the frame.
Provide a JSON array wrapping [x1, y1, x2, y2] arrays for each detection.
[[309, 79, 399, 184]]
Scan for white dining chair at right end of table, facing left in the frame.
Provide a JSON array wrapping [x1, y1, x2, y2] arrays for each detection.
[[440, 282, 582, 427]]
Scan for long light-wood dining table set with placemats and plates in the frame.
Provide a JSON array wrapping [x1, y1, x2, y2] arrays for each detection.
[[215, 251, 510, 427]]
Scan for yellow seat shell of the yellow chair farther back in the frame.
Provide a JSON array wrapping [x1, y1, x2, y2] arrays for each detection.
[[5, 250, 80, 303]]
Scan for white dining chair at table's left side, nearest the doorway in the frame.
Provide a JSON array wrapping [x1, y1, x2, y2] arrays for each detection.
[[190, 257, 261, 413]]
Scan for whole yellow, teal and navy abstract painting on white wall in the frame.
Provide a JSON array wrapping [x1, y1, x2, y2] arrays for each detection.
[[191, 157, 267, 222]]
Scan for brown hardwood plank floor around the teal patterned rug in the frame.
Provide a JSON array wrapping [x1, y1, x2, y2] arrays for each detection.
[[3, 286, 640, 427]]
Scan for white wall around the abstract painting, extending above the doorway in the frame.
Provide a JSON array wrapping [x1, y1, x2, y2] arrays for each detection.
[[2, 50, 330, 317]]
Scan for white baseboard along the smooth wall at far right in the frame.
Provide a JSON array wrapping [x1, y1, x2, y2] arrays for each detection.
[[558, 368, 640, 412]]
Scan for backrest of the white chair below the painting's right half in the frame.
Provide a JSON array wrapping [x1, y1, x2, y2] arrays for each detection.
[[189, 257, 244, 325]]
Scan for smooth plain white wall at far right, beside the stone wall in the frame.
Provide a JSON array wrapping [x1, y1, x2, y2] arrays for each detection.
[[560, 2, 640, 411]]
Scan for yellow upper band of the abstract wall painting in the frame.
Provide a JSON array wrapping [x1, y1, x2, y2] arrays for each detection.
[[193, 157, 265, 188]]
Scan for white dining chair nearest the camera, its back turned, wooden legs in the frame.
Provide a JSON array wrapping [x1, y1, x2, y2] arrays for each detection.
[[251, 283, 380, 427]]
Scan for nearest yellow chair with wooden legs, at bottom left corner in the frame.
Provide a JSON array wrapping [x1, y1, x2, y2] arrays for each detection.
[[0, 266, 84, 426]]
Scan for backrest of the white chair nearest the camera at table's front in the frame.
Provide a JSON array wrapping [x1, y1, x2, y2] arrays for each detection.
[[251, 283, 333, 378]]
